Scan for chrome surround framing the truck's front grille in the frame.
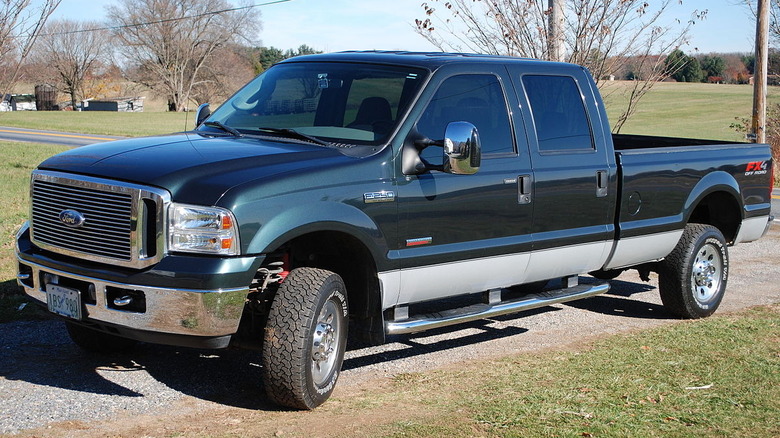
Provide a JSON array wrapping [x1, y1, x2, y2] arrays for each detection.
[[30, 170, 171, 269]]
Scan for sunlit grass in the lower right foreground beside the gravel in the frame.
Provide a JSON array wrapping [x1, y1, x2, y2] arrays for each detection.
[[368, 305, 780, 437]]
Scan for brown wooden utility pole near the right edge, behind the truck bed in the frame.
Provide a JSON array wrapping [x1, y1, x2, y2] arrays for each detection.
[[748, 0, 769, 143]]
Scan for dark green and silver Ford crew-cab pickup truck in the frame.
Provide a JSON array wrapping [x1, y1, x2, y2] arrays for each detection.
[[16, 52, 772, 409]]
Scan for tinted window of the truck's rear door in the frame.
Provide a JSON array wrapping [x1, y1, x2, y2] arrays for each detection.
[[523, 75, 593, 152]]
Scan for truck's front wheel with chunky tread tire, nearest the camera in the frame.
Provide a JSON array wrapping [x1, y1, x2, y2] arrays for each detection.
[[263, 268, 349, 409]]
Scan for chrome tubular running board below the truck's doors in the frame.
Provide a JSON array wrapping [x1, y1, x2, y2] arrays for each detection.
[[385, 283, 609, 335]]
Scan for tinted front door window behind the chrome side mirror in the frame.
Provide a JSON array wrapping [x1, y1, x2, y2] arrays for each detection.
[[417, 74, 515, 160]]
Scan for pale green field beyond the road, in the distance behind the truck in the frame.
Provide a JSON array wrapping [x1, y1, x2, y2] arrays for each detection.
[[0, 81, 780, 141]]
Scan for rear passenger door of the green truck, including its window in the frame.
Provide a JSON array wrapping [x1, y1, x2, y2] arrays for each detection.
[[510, 65, 617, 281]]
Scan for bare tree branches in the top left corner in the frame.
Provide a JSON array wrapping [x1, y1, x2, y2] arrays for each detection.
[[0, 0, 60, 94]]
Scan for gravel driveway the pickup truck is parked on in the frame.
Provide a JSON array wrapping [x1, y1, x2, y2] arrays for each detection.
[[0, 224, 780, 438]]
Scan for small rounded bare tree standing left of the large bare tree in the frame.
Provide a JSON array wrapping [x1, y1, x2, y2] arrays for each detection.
[[38, 20, 108, 108]]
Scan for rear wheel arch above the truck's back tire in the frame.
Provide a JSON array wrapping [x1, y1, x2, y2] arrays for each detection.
[[683, 171, 743, 242]]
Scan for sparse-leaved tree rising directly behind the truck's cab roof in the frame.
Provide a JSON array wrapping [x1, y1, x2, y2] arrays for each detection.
[[415, 0, 706, 132]]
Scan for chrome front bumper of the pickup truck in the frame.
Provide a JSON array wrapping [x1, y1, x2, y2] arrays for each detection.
[[17, 257, 249, 336]]
